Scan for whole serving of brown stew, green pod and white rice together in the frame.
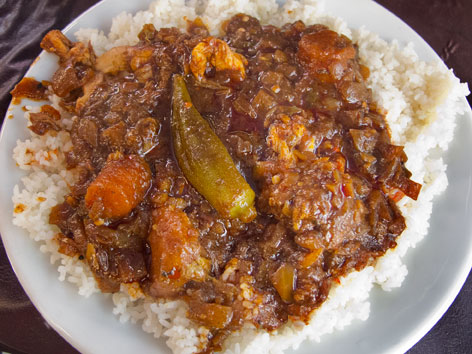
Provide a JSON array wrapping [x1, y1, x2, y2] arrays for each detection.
[[7, 1, 467, 353]]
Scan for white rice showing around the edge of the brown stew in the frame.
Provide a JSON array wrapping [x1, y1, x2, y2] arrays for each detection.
[[13, 0, 469, 354]]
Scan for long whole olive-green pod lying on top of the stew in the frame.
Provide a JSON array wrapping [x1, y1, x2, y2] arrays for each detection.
[[171, 75, 256, 222]]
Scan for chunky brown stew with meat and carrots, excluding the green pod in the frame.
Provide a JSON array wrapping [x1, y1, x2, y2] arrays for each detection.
[[35, 15, 421, 352]]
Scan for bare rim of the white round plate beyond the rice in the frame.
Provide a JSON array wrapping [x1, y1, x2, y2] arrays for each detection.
[[0, 0, 472, 354]]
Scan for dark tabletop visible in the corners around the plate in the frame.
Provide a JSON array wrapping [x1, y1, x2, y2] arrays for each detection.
[[0, 0, 472, 354]]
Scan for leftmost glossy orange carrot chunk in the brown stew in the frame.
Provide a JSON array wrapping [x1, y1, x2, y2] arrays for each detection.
[[85, 155, 151, 223]]
